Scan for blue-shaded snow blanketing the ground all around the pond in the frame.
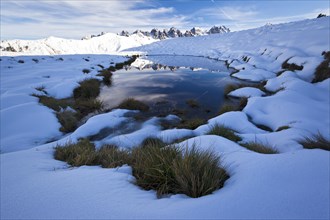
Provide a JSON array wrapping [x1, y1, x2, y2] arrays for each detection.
[[0, 17, 330, 219]]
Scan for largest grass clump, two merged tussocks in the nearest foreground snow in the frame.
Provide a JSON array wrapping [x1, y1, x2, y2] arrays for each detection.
[[132, 144, 228, 198]]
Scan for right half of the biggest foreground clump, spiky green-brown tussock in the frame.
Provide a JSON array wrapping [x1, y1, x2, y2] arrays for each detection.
[[173, 146, 229, 198]]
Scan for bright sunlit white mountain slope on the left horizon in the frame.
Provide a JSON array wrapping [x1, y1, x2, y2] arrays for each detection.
[[0, 33, 156, 56]]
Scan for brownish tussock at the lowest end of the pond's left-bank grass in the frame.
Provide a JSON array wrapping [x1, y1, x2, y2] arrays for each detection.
[[56, 111, 79, 133]]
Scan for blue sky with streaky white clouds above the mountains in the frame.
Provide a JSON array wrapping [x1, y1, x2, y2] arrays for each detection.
[[0, 0, 330, 40]]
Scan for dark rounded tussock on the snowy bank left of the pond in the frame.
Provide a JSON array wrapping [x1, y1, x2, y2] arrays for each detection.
[[73, 79, 100, 99]]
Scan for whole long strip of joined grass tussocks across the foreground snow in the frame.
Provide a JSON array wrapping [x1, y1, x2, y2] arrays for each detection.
[[54, 139, 229, 198]]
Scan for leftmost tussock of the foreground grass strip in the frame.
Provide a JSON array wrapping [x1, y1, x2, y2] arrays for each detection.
[[54, 139, 96, 167]]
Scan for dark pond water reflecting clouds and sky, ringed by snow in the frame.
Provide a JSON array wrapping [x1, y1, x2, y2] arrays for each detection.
[[100, 56, 238, 119]]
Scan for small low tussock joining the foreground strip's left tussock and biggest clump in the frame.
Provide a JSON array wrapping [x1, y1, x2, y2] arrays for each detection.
[[95, 145, 131, 168]]
